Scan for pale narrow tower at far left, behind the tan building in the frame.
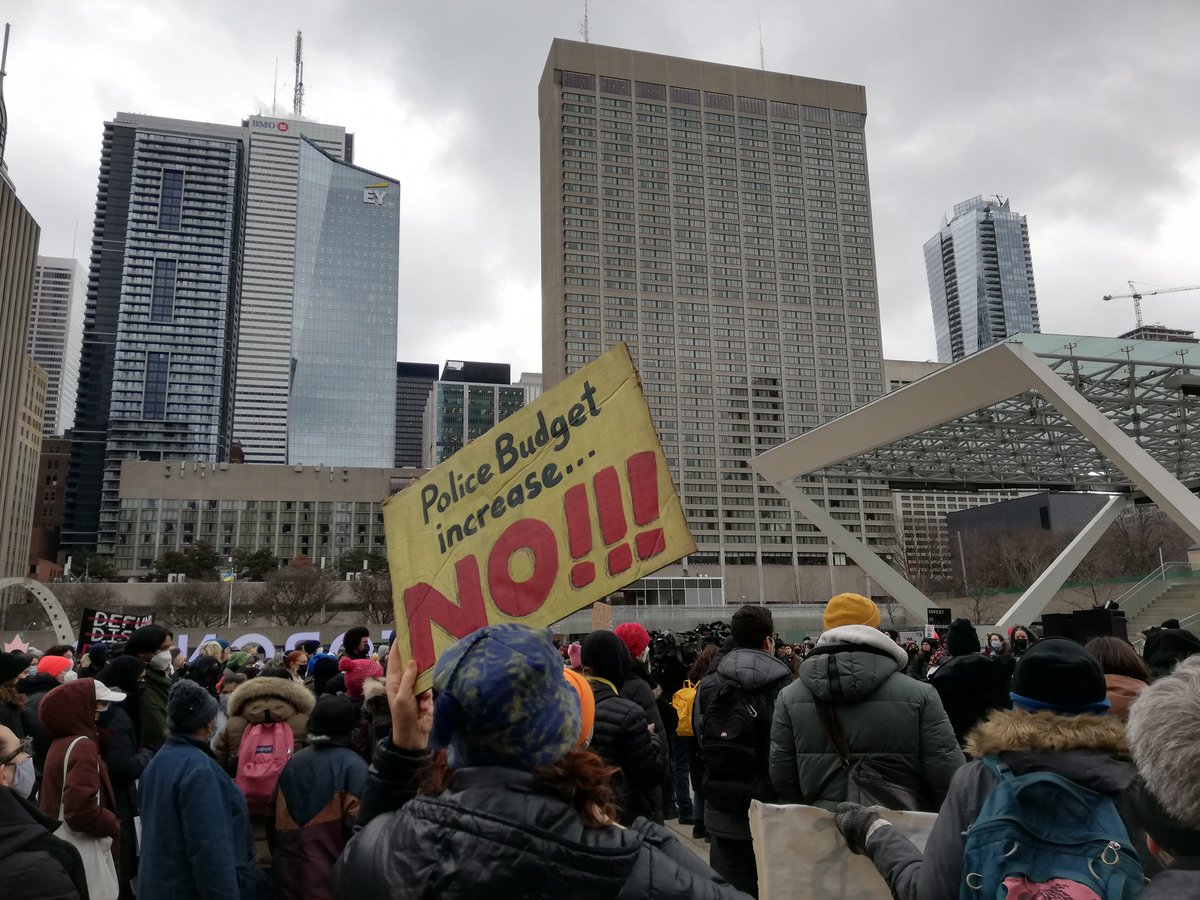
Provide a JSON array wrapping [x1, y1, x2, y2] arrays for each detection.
[[25, 257, 86, 437]]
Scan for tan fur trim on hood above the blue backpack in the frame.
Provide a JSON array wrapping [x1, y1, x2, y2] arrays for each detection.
[[965, 709, 1132, 760]]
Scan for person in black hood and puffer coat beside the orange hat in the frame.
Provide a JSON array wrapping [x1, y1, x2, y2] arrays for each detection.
[[582, 631, 667, 826]]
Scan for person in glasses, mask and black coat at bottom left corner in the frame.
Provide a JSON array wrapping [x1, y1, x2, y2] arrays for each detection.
[[0, 726, 88, 900]]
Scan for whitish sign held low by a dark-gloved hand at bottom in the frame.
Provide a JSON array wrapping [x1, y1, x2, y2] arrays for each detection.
[[750, 800, 937, 900]]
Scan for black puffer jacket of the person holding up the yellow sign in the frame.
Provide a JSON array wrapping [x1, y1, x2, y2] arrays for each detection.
[[334, 740, 746, 900]]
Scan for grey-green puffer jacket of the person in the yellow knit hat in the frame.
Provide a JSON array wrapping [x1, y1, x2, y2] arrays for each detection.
[[770, 625, 966, 809]]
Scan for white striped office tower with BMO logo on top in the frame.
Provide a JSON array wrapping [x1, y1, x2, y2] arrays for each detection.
[[233, 115, 350, 462]]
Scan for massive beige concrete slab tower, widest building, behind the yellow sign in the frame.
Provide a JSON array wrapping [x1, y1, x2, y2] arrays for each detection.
[[539, 41, 892, 601]]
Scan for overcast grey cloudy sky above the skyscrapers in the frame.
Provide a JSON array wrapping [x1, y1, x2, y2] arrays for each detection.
[[7, 0, 1200, 373]]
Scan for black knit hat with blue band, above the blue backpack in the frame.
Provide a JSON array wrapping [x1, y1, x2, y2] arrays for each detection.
[[1013, 637, 1109, 713]]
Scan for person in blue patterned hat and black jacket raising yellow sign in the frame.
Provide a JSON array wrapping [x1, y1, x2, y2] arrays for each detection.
[[332, 623, 744, 900]]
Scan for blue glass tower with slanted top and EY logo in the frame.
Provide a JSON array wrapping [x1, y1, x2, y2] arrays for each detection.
[[288, 140, 400, 467]]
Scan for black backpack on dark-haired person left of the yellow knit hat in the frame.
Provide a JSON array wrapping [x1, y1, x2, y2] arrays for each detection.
[[700, 680, 773, 815]]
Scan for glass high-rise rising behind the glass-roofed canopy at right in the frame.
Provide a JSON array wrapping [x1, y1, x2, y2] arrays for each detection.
[[925, 197, 1042, 362]]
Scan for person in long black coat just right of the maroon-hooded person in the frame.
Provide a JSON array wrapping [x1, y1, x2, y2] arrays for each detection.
[[96, 656, 154, 900]]
